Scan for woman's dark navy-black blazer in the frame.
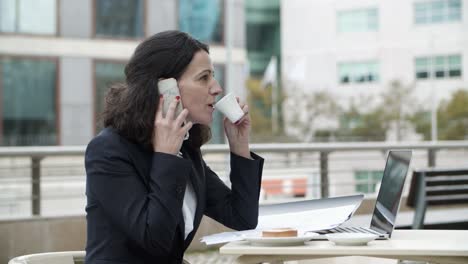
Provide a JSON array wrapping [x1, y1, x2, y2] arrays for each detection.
[[85, 128, 263, 264]]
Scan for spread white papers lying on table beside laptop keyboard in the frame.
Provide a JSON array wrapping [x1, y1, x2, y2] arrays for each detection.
[[201, 205, 356, 245]]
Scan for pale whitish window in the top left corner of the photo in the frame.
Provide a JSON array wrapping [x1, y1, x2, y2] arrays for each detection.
[[0, 0, 57, 35]]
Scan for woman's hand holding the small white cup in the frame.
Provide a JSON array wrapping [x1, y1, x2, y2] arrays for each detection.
[[224, 97, 251, 159]]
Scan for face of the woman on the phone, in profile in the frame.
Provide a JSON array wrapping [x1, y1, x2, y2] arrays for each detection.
[[178, 50, 222, 125]]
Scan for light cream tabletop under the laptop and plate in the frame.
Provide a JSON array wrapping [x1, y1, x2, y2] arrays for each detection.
[[220, 230, 468, 263]]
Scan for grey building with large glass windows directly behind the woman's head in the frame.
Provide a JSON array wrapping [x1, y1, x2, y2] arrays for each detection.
[[0, 0, 245, 146]]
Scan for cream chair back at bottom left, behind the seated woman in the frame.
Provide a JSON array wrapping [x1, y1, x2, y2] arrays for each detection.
[[8, 251, 85, 264]]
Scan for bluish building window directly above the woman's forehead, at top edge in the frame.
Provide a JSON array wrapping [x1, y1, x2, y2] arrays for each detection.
[[179, 0, 224, 43]]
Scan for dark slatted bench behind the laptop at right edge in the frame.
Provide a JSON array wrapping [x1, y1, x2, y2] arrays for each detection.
[[407, 168, 468, 229]]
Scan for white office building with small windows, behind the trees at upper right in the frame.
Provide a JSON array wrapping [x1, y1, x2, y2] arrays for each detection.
[[281, 0, 468, 107]]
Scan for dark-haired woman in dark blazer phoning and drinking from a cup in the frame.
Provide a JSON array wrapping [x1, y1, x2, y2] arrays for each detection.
[[85, 31, 263, 264]]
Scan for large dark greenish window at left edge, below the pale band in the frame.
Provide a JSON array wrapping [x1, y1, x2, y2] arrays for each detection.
[[0, 58, 58, 146]]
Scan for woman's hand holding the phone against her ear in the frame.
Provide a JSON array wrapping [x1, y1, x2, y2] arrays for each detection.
[[153, 96, 192, 155]]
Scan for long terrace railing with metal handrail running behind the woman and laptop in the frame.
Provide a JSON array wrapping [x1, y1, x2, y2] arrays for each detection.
[[0, 141, 468, 218]]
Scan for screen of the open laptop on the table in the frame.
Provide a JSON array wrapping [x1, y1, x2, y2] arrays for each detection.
[[370, 150, 411, 237]]
